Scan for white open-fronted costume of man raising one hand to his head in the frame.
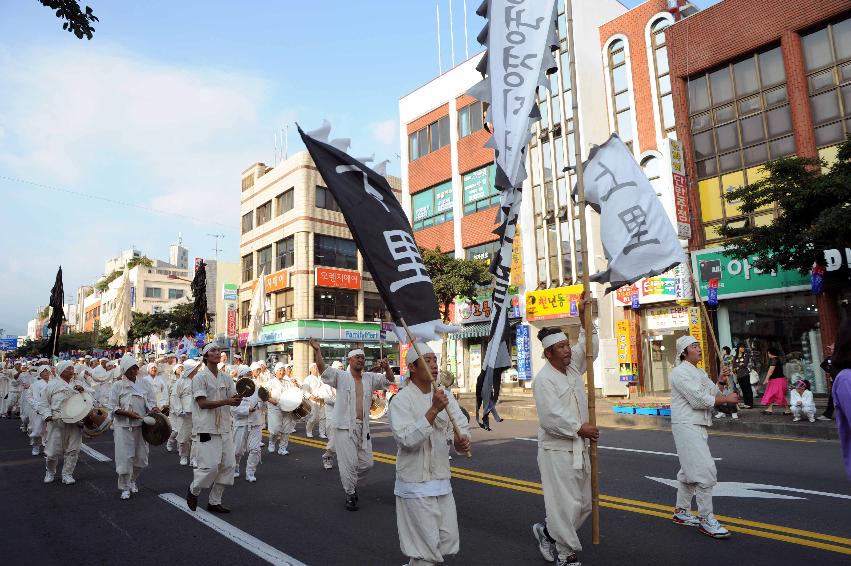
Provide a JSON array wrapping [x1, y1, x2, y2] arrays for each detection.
[[322, 366, 390, 495]]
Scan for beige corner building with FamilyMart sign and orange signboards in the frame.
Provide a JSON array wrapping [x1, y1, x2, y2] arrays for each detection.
[[239, 151, 401, 376]]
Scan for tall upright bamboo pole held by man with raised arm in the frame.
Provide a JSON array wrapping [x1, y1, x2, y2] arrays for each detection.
[[562, 0, 600, 544]]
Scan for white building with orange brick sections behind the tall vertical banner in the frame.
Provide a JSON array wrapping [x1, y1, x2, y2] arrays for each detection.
[[399, 0, 626, 393]]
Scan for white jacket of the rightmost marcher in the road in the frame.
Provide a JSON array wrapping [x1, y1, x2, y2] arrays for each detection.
[[671, 362, 721, 426]]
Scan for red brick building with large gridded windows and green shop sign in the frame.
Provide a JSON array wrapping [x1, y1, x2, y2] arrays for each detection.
[[665, 0, 851, 392]]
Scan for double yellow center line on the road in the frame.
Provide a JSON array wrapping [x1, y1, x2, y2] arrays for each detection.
[[286, 433, 851, 554]]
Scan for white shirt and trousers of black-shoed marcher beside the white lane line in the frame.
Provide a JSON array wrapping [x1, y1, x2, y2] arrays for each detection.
[[189, 366, 236, 505]]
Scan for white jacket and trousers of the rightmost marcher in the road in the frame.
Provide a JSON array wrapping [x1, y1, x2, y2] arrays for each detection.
[[671, 362, 721, 518]]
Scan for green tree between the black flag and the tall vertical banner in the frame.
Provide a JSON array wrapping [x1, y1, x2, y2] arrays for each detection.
[[420, 246, 493, 369]]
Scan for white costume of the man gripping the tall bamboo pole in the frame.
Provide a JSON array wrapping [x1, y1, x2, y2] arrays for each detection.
[[532, 329, 599, 558]]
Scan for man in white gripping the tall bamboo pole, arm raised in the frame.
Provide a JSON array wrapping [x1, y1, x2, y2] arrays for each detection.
[[528, 316, 600, 566]]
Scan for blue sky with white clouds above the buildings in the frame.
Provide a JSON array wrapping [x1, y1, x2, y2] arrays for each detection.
[[0, 0, 714, 335]]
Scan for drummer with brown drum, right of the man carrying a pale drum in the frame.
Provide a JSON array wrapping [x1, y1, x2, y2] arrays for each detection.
[[109, 354, 159, 499]]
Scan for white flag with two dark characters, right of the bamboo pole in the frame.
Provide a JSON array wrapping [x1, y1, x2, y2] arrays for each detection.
[[584, 134, 685, 291]]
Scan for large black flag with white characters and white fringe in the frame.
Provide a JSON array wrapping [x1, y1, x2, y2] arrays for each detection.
[[298, 128, 454, 340]]
